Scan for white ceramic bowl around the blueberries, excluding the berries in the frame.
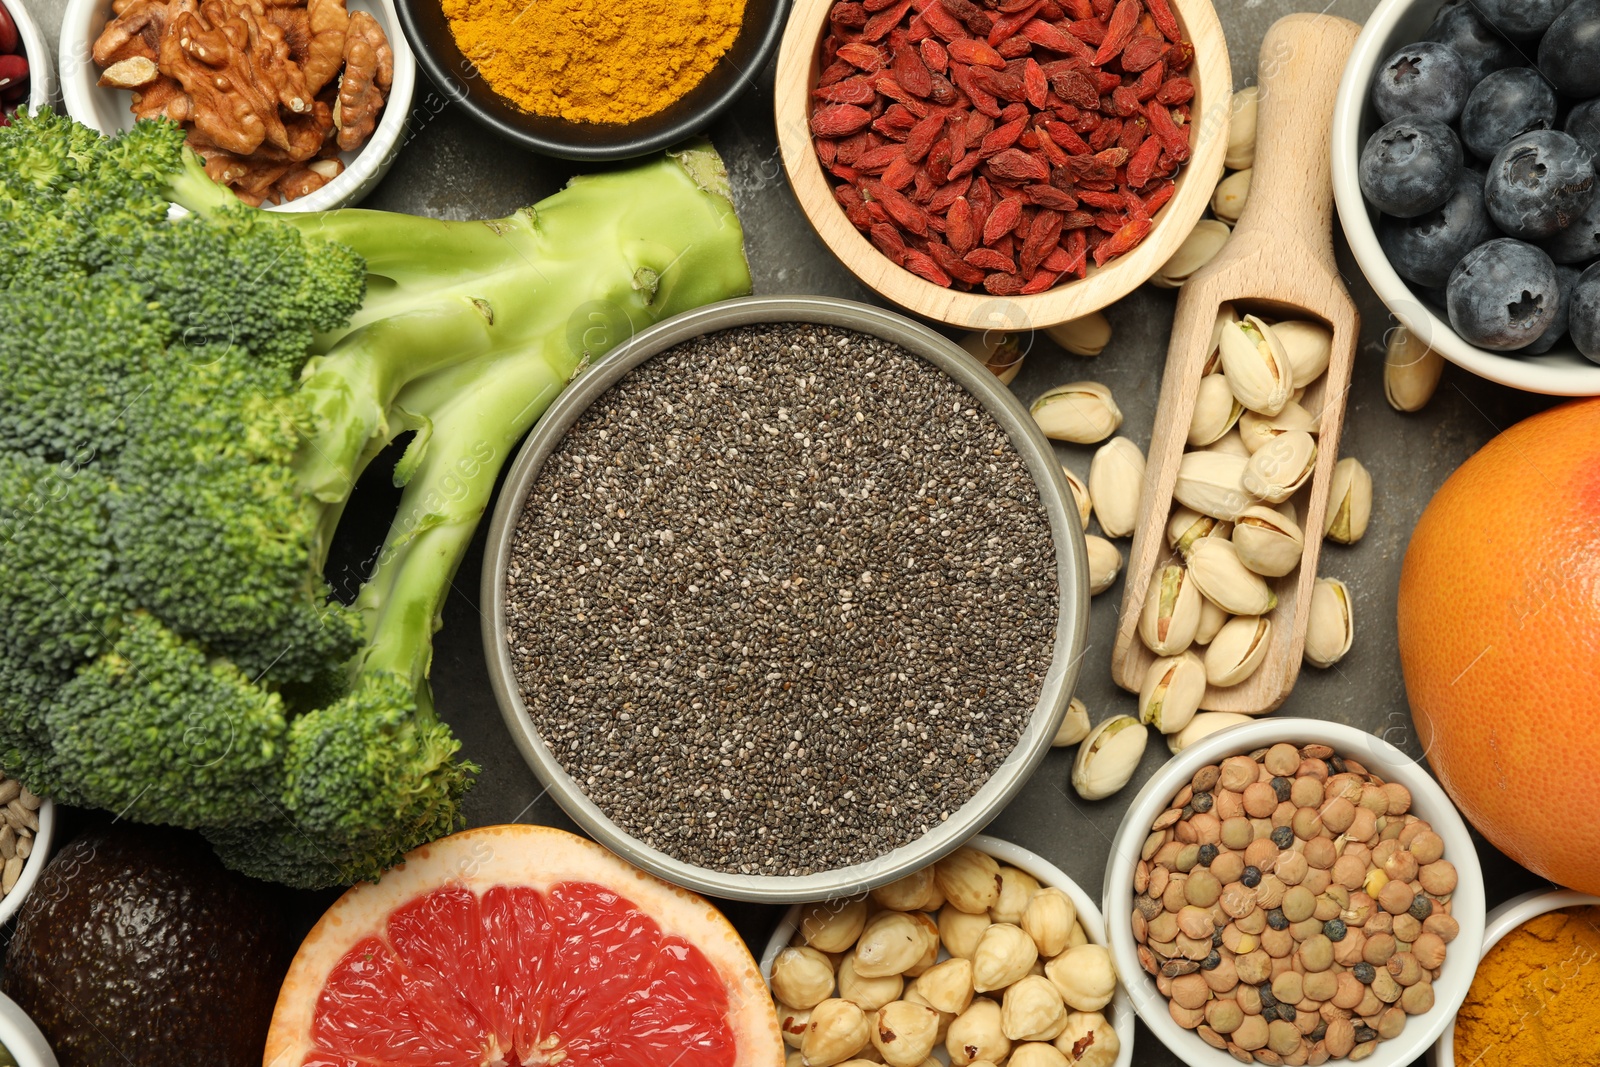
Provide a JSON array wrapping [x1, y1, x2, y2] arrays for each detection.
[[1333, 0, 1600, 397]]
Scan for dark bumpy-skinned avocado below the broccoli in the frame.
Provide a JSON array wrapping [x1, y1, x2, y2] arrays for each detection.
[[0, 824, 290, 1067]]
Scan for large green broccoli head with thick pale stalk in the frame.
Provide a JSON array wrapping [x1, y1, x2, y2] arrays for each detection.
[[0, 112, 749, 886]]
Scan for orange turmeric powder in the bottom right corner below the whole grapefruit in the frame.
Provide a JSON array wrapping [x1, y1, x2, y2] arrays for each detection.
[[1442, 907, 1600, 1067]]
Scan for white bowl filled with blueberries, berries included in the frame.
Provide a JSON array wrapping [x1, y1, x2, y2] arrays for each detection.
[[1333, 0, 1600, 397]]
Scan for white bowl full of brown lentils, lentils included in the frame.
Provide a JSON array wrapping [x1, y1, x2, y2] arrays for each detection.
[[1102, 718, 1485, 1067]]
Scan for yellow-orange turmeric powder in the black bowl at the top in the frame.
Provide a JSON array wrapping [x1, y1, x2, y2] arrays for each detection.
[[443, 0, 744, 123]]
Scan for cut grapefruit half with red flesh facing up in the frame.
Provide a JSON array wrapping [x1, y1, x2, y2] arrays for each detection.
[[264, 825, 784, 1067]]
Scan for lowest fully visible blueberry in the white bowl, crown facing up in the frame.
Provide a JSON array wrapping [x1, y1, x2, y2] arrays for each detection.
[[1450, 237, 1576, 352]]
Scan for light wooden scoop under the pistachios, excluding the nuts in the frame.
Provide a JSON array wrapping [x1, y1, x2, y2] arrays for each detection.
[[1112, 14, 1360, 715]]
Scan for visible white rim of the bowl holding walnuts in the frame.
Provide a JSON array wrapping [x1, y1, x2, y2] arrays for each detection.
[[57, 0, 416, 211]]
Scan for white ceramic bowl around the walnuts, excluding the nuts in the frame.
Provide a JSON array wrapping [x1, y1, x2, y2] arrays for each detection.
[[58, 0, 412, 211]]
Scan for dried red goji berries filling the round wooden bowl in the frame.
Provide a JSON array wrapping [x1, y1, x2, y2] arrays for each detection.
[[811, 0, 1195, 296]]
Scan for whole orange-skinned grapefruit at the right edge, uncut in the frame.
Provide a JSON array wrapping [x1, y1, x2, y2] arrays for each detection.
[[1400, 398, 1600, 893]]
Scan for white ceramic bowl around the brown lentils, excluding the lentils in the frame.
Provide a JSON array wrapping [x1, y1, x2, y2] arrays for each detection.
[[1102, 718, 1485, 1067]]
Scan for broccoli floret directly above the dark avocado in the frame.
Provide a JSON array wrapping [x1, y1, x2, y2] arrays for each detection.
[[45, 611, 286, 829]]
